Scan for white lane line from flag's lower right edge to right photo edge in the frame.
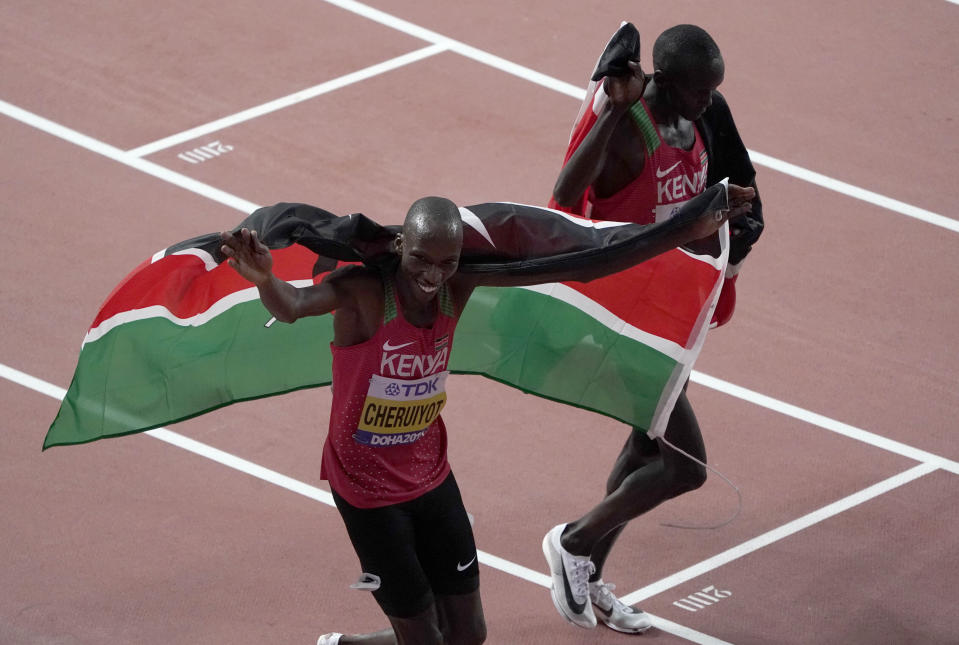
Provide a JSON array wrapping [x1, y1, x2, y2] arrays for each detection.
[[690, 370, 959, 475]]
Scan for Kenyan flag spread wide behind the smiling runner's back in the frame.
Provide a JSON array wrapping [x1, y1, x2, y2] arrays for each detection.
[[43, 194, 727, 449]]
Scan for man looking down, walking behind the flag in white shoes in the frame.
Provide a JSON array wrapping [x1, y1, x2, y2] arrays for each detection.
[[543, 23, 763, 633]]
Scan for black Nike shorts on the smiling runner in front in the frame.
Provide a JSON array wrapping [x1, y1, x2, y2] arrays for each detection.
[[333, 473, 479, 618]]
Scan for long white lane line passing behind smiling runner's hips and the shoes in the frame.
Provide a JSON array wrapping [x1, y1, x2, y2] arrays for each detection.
[[0, 363, 725, 645]]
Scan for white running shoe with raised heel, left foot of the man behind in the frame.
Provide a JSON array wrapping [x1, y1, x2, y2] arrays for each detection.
[[543, 524, 596, 629]]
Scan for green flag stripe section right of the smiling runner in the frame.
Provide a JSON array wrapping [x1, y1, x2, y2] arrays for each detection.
[[450, 287, 680, 429]]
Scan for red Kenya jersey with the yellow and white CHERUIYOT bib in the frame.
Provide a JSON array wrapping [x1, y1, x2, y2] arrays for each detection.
[[320, 276, 457, 508]]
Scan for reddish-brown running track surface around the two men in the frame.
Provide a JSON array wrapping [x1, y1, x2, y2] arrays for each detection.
[[0, 0, 959, 645]]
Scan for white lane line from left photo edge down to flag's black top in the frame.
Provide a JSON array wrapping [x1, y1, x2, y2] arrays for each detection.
[[0, 100, 258, 213]]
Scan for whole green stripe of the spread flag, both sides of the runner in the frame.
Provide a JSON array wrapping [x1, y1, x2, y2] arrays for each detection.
[[43, 287, 681, 449]]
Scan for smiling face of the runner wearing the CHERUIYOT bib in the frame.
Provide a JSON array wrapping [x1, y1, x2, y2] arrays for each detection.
[[400, 233, 463, 302]]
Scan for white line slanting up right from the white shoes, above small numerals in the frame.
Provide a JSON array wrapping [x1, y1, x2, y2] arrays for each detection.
[[620, 464, 937, 605]]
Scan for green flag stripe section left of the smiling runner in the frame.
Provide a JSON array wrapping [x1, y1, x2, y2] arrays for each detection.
[[43, 300, 333, 449]]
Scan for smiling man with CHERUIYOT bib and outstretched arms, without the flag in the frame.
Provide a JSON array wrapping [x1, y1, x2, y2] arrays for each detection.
[[221, 192, 753, 645]]
